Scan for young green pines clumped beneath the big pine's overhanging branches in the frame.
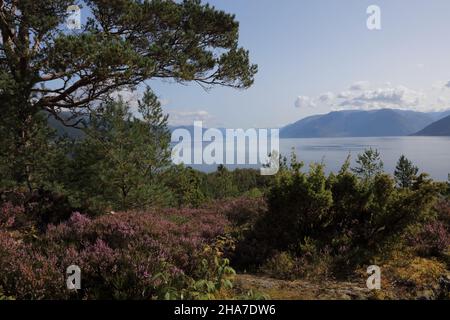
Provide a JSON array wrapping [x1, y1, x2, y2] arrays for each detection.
[[68, 89, 170, 210]]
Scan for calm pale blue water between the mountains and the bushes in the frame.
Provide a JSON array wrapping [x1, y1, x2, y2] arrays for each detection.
[[194, 137, 450, 180]]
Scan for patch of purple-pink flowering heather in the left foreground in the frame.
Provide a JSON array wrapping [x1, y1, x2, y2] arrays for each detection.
[[0, 202, 233, 299]]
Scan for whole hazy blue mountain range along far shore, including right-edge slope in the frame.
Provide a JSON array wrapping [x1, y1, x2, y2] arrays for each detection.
[[48, 109, 450, 138]]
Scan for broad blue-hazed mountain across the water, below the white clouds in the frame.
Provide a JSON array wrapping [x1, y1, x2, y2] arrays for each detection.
[[280, 109, 439, 138]]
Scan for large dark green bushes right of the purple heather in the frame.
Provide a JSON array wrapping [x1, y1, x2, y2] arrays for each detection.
[[233, 150, 450, 278]]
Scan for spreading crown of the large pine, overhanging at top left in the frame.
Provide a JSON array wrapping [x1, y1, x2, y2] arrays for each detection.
[[0, 0, 257, 125]]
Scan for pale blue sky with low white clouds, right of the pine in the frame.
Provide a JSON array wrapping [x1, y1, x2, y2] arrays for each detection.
[[125, 0, 450, 128]]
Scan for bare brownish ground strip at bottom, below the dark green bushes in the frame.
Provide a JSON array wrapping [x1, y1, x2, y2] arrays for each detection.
[[235, 274, 370, 300]]
